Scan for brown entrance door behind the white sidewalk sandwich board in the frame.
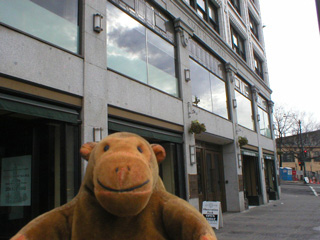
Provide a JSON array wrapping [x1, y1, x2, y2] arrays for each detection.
[[196, 148, 227, 212]]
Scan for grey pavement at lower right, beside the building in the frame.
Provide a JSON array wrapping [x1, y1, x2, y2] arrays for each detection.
[[215, 183, 320, 240]]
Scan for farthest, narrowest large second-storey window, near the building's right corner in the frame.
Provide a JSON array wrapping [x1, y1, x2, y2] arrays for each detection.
[[257, 95, 271, 138]]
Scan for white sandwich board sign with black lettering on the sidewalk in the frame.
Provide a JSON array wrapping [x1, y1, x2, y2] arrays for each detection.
[[202, 201, 223, 229]]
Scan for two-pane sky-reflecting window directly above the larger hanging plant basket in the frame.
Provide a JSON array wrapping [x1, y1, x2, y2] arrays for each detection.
[[190, 59, 228, 118]]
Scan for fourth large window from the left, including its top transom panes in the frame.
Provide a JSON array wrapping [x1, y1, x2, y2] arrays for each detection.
[[235, 78, 255, 130]]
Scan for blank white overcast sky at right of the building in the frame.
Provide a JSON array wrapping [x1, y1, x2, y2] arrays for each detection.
[[260, 0, 320, 122]]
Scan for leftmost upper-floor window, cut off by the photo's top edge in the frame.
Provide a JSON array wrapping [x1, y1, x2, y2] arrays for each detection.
[[189, 0, 219, 33]]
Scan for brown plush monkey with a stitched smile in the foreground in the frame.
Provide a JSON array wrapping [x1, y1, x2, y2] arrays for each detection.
[[12, 133, 216, 240]]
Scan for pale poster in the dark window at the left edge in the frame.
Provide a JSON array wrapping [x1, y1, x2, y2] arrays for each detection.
[[0, 155, 31, 206]]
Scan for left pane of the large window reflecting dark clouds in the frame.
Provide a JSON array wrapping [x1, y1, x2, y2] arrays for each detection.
[[107, 3, 147, 83]]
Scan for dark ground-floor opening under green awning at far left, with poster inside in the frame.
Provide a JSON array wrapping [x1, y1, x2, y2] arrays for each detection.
[[0, 114, 80, 239]]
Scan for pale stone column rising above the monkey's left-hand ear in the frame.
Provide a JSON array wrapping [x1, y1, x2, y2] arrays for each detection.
[[81, 0, 108, 176]]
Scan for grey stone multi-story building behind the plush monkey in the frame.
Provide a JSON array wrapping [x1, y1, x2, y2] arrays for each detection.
[[0, 0, 279, 239]]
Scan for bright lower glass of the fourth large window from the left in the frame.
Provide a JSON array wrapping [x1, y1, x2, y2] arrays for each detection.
[[235, 91, 254, 130]]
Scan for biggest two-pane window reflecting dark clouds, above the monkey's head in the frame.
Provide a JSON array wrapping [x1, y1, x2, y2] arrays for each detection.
[[107, 2, 179, 97]]
